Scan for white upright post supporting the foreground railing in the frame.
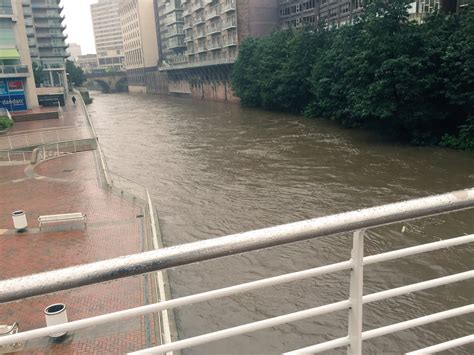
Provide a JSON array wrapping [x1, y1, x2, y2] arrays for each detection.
[[347, 229, 365, 355]]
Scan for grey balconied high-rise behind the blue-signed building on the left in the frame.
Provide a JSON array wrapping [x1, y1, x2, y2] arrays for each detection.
[[22, 0, 69, 92]]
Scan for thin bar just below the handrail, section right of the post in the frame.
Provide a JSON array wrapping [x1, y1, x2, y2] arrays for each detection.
[[364, 234, 474, 265]]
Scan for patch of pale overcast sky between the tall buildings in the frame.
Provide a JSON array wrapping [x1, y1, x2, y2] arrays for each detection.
[[62, 0, 97, 54]]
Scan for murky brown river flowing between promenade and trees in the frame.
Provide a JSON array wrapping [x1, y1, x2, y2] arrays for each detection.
[[89, 93, 474, 354]]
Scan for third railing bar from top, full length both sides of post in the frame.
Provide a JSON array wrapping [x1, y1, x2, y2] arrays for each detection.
[[130, 272, 472, 354]]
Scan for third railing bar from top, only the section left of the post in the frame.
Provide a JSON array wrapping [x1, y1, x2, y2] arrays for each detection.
[[131, 300, 351, 354]]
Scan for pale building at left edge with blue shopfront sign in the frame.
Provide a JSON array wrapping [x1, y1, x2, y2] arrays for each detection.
[[0, 0, 38, 112]]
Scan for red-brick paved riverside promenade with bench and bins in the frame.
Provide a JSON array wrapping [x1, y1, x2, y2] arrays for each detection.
[[0, 104, 156, 354]]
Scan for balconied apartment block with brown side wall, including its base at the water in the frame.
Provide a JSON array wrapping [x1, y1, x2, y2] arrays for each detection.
[[156, 0, 279, 101]]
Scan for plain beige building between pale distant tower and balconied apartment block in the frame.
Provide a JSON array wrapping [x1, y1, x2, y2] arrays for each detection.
[[119, 0, 159, 93]]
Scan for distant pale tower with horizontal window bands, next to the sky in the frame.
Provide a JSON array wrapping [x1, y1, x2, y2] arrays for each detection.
[[91, 0, 125, 71]]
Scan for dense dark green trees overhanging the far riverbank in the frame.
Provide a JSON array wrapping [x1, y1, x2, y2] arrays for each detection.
[[232, 0, 474, 149]]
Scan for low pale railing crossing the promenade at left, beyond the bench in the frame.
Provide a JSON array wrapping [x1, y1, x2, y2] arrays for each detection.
[[0, 127, 92, 150]]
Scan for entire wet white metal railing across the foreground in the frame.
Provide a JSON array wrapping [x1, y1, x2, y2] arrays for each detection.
[[0, 188, 474, 354]]
